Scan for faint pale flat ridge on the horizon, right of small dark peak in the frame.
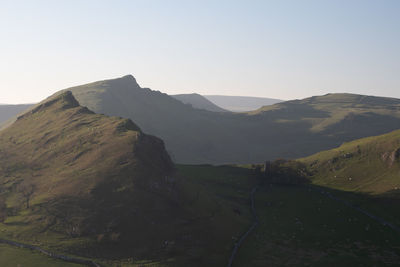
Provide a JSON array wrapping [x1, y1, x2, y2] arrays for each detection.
[[204, 95, 283, 112]]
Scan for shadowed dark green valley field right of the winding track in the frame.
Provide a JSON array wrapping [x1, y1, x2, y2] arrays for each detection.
[[233, 185, 400, 266]]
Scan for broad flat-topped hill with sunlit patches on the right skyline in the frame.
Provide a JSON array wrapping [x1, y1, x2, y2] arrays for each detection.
[[251, 94, 400, 141]]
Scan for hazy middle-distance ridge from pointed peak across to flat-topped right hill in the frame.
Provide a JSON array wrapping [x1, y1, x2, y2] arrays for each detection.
[[50, 75, 400, 164]]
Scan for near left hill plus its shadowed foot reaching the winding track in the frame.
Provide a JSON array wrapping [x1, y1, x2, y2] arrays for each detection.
[[0, 91, 258, 266]]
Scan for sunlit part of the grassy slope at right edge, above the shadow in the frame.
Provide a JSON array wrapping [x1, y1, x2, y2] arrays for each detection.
[[300, 127, 400, 194]]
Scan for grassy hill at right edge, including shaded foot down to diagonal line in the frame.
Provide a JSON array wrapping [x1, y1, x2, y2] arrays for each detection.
[[299, 130, 400, 246]]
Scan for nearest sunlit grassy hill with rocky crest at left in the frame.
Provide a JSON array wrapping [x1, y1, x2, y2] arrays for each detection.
[[0, 90, 186, 260]]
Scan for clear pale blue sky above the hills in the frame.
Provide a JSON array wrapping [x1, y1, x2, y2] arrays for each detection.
[[0, 0, 400, 103]]
